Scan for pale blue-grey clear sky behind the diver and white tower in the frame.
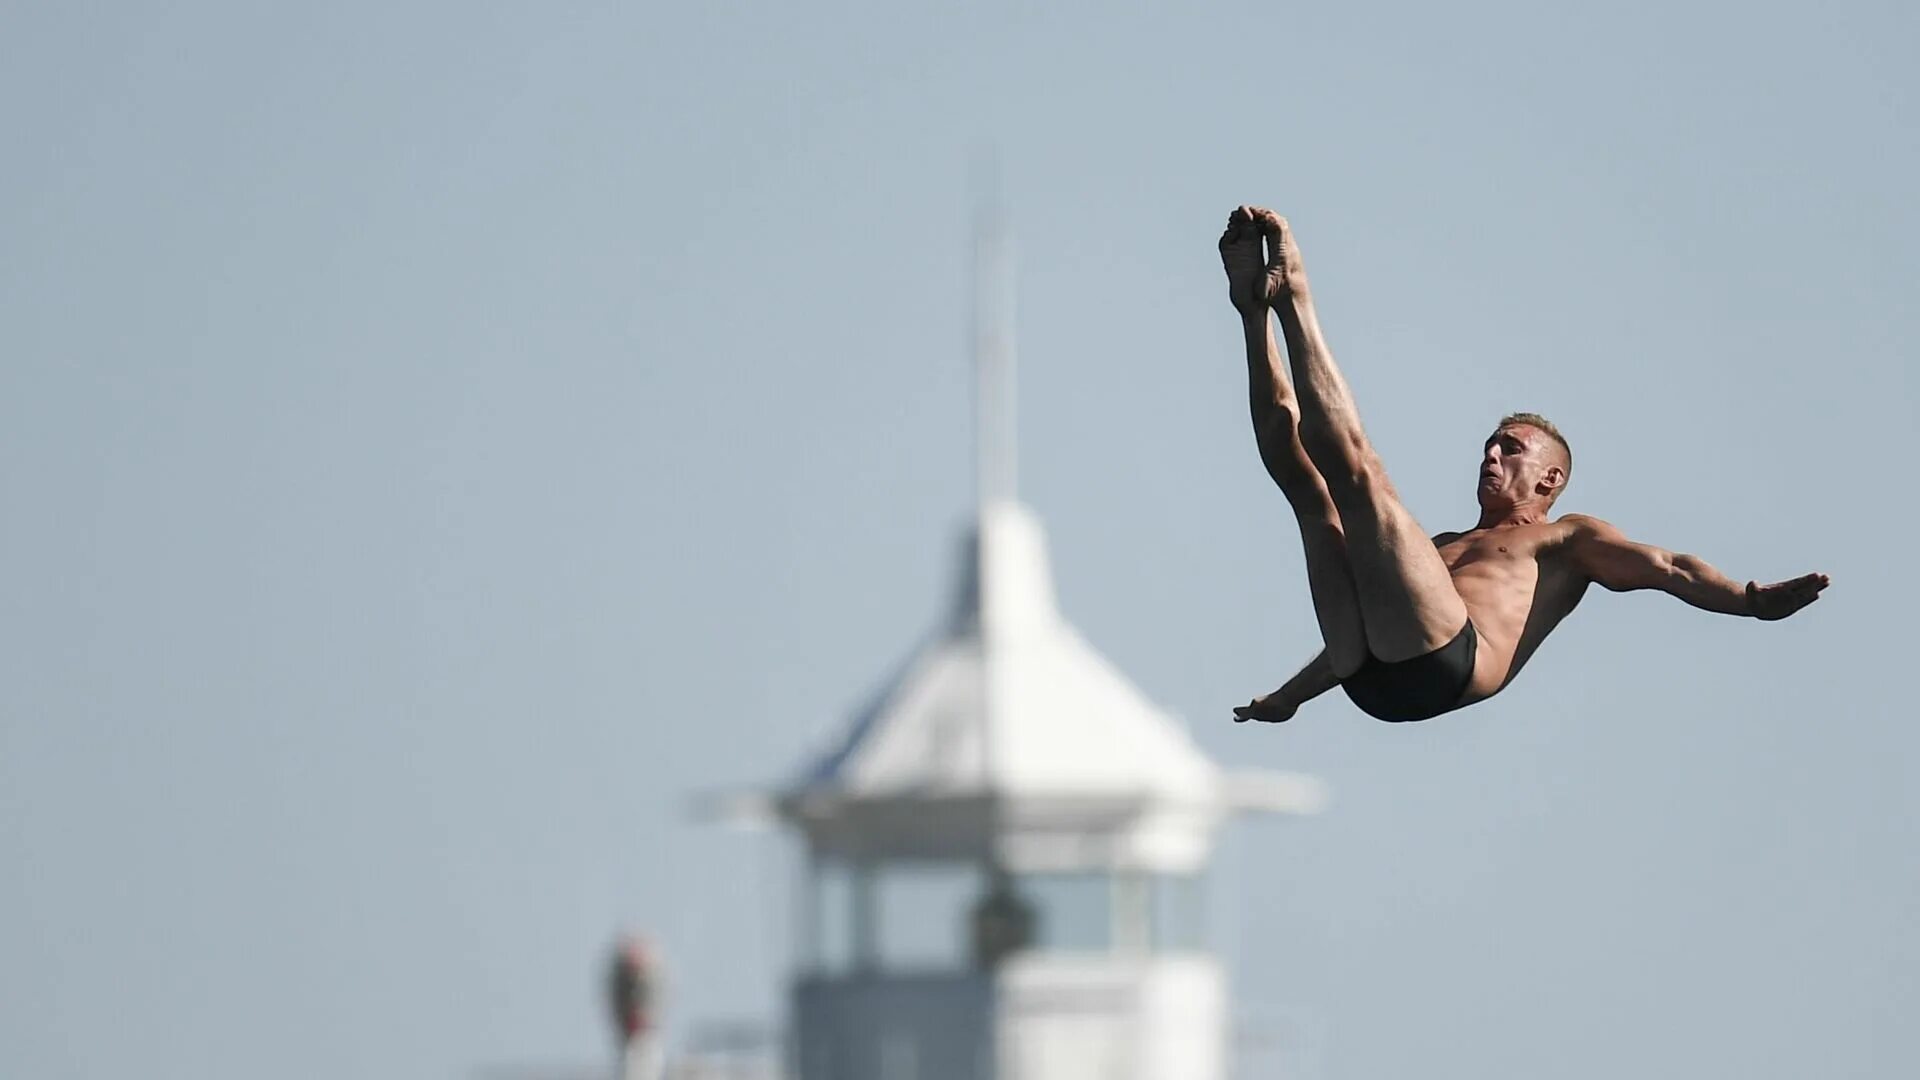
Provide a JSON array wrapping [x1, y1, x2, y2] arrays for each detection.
[[0, 2, 1920, 1080]]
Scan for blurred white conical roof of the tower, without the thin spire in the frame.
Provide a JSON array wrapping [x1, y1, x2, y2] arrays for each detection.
[[781, 500, 1317, 872]]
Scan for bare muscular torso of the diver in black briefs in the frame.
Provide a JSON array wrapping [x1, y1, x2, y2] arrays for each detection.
[[1434, 519, 1590, 703]]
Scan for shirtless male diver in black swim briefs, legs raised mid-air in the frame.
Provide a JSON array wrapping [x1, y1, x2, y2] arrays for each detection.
[[1219, 206, 1828, 723]]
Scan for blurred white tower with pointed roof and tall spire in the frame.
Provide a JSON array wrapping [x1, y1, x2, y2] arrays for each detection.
[[764, 197, 1321, 1080]]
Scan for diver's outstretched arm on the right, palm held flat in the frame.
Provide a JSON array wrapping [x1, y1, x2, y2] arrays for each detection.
[[1563, 513, 1830, 621]]
